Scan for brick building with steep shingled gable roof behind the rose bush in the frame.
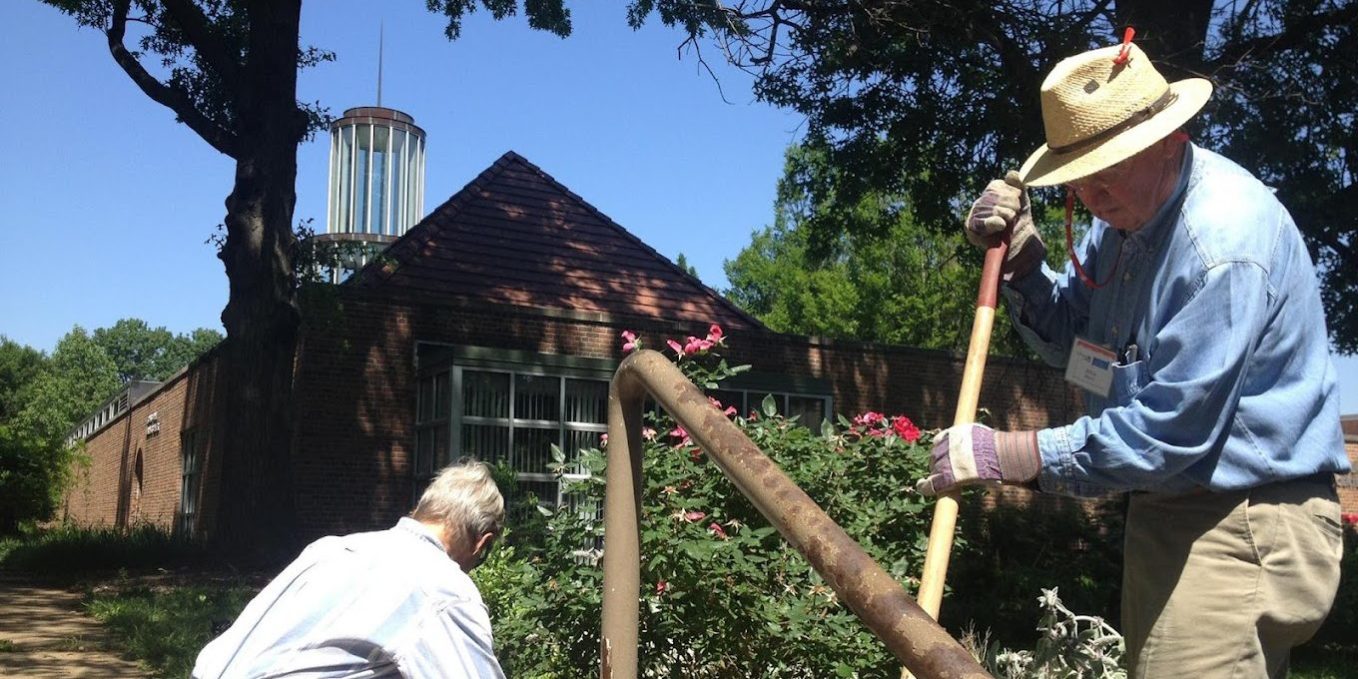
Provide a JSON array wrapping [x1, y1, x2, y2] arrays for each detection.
[[55, 152, 1358, 538]]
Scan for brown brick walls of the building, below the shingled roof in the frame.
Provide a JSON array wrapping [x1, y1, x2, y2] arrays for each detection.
[[64, 289, 1358, 539]]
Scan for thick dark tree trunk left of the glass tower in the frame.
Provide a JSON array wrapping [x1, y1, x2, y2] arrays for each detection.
[[209, 0, 306, 564]]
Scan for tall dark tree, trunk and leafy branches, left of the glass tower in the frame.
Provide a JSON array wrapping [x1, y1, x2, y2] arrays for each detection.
[[42, 0, 570, 562]]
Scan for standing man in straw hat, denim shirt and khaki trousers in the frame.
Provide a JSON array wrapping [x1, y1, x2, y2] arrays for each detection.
[[919, 39, 1348, 676]]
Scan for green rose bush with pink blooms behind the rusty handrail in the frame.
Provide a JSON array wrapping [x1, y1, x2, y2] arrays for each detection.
[[473, 336, 929, 678]]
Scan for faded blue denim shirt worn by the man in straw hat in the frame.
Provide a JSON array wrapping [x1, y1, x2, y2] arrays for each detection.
[[1004, 145, 1348, 496]]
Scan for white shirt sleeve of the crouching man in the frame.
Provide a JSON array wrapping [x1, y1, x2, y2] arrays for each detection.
[[399, 602, 505, 679]]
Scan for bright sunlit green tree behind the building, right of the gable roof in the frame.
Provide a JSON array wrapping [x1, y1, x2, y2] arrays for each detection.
[[725, 147, 1042, 356]]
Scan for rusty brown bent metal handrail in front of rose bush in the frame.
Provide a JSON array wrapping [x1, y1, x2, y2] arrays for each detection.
[[599, 350, 990, 679]]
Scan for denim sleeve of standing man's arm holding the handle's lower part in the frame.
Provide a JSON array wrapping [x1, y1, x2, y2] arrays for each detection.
[[1038, 261, 1271, 494]]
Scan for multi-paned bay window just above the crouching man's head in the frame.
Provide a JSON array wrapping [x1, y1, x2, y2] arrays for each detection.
[[416, 365, 608, 516]]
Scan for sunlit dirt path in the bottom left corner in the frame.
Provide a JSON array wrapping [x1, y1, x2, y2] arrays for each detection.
[[0, 579, 147, 679]]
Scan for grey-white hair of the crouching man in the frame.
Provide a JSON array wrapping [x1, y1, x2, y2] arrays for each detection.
[[410, 459, 505, 540]]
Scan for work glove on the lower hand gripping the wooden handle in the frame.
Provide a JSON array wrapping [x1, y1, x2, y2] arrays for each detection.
[[915, 424, 1042, 496]]
